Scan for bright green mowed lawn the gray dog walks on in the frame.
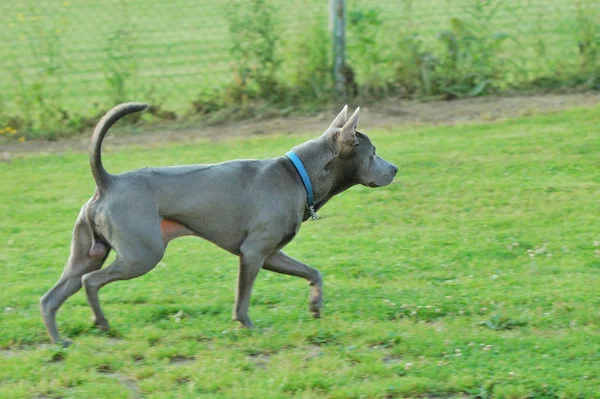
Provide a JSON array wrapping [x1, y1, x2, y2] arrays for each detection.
[[0, 107, 600, 399]]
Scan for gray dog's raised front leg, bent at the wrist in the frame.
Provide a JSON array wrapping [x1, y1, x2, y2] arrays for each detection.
[[263, 251, 323, 318]]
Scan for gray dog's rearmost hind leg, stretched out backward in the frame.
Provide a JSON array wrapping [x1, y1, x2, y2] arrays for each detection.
[[40, 211, 109, 346]]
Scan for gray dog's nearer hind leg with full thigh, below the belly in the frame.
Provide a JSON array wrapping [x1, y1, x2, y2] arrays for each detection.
[[82, 220, 165, 330]]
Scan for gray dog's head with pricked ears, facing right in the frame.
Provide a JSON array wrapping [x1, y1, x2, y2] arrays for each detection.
[[325, 106, 398, 187]]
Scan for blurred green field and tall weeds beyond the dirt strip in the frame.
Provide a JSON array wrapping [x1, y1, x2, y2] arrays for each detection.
[[0, 0, 600, 138]]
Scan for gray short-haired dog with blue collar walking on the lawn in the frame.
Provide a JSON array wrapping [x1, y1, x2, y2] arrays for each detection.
[[40, 103, 398, 345]]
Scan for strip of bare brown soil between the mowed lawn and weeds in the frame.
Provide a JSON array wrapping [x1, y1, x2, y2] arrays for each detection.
[[0, 93, 600, 157]]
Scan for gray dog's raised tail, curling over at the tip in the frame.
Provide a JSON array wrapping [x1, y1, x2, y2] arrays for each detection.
[[90, 103, 148, 193]]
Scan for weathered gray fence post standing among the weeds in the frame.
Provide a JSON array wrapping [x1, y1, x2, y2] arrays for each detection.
[[329, 0, 347, 100]]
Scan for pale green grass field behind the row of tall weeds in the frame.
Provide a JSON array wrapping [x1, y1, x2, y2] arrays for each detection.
[[0, 0, 600, 137]]
